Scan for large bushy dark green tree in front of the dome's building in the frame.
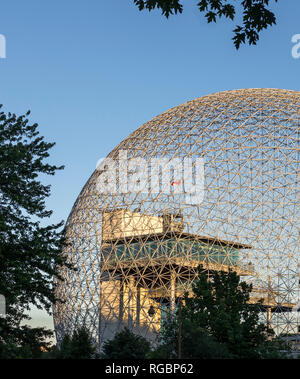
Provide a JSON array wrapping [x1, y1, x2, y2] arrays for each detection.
[[154, 267, 288, 359]]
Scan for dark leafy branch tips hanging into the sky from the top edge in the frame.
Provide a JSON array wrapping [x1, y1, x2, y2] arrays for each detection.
[[134, 0, 278, 49]]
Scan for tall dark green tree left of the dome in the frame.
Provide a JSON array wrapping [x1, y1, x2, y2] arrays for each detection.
[[0, 106, 70, 360]]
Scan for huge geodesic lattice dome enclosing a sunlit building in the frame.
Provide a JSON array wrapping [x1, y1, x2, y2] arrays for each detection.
[[54, 89, 300, 347]]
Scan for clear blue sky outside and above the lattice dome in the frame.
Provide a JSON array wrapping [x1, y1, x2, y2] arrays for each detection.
[[0, 0, 300, 336]]
